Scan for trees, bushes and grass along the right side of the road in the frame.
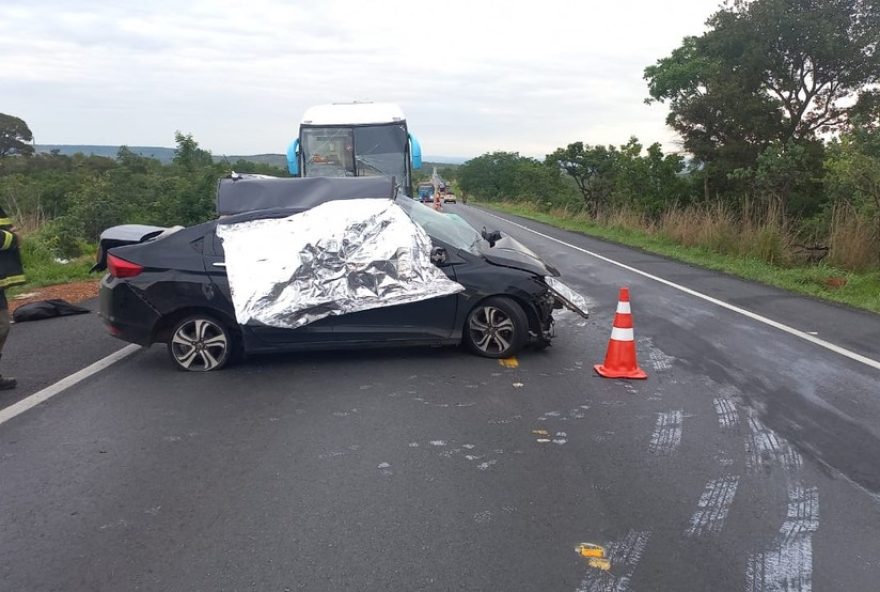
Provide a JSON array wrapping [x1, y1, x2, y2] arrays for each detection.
[[455, 0, 880, 312]]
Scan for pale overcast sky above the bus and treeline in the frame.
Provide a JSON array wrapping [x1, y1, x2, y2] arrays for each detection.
[[0, 0, 719, 157]]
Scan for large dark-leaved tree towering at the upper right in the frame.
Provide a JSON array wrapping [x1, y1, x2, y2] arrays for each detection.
[[645, 0, 880, 201]]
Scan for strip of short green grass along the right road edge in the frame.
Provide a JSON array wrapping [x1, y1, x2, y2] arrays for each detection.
[[480, 202, 880, 313]]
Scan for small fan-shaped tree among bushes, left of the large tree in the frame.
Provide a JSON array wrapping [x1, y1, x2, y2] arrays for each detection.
[[545, 142, 618, 218]]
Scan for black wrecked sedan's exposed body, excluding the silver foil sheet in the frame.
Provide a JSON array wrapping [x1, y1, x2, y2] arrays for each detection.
[[100, 180, 586, 371]]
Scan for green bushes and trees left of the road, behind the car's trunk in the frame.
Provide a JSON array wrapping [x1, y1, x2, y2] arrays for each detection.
[[0, 123, 286, 293]]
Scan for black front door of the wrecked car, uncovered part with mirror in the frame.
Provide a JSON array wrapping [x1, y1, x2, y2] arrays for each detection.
[[334, 241, 463, 343]]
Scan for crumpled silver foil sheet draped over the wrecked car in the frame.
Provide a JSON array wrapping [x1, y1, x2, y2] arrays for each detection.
[[217, 199, 464, 329]]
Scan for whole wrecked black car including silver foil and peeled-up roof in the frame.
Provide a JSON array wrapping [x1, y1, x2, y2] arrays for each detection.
[[96, 175, 587, 371]]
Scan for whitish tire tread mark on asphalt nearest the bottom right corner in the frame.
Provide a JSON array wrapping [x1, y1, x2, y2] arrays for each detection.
[[746, 484, 819, 592]]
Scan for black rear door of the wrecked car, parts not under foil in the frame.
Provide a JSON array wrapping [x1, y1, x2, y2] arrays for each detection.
[[204, 232, 333, 347]]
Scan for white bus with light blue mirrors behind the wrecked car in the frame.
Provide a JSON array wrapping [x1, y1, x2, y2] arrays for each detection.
[[287, 103, 422, 196]]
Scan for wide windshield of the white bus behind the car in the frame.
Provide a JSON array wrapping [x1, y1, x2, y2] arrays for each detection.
[[301, 124, 408, 183]]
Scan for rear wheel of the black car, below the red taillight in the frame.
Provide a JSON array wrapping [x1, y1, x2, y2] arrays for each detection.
[[168, 314, 238, 372]]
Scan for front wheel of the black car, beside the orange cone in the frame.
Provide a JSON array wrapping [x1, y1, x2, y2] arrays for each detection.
[[463, 296, 529, 358]]
